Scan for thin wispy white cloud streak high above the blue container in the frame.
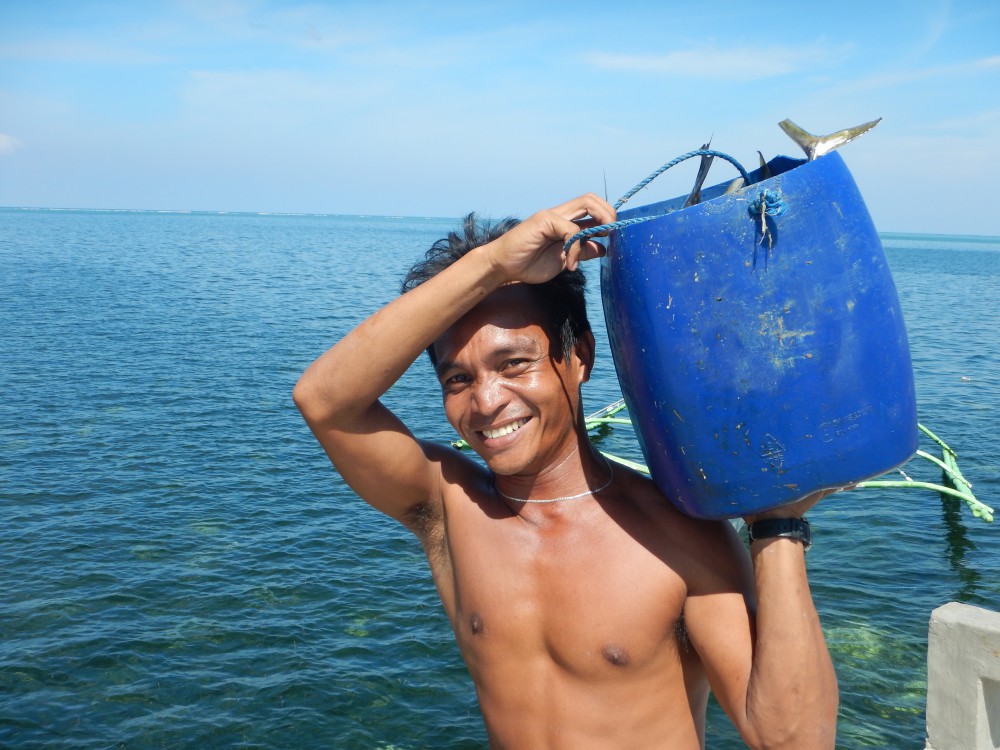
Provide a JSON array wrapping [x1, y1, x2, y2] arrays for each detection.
[[588, 44, 850, 81]]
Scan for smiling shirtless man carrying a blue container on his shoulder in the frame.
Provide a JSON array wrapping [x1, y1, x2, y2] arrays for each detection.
[[294, 195, 838, 750]]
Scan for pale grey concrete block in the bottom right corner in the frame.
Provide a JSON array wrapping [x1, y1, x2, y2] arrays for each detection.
[[926, 602, 1000, 750]]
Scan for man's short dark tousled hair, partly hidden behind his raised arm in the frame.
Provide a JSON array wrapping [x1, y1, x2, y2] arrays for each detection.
[[402, 213, 590, 366]]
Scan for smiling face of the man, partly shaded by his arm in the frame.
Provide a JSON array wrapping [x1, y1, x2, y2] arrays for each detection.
[[434, 284, 593, 475]]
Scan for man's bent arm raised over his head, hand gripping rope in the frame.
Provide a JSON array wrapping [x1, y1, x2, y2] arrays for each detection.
[[293, 195, 615, 519]]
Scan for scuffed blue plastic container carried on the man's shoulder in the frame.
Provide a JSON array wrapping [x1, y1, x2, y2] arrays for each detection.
[[601, 153, 917, 518]]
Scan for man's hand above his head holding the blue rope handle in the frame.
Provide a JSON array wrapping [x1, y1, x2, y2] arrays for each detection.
[[484, 193, 616, 284]]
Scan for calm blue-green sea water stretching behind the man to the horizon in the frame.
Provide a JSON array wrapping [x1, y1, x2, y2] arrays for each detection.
[[0, 209, 1000, 749]]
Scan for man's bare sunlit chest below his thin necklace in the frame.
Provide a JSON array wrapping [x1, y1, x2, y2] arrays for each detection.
[[439, 506, 686, 676]]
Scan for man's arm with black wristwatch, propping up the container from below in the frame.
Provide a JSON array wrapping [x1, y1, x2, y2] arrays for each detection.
[[685, 493, 839, 750]]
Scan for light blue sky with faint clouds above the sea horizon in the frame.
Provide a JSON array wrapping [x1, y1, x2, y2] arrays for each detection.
[[0, 0, 1000, 236]]
